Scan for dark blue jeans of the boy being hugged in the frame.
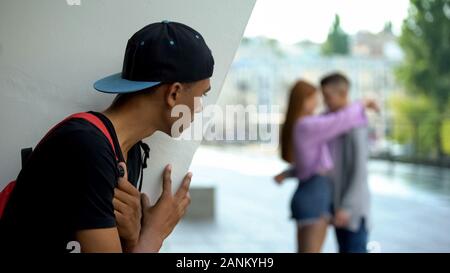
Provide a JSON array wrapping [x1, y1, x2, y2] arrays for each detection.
[[335, 219, 368, 253]]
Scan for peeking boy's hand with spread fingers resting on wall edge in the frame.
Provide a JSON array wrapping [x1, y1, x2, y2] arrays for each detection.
[[134, 165, 192, 252]]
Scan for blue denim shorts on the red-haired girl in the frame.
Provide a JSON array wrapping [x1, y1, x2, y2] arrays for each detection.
[[291, 175, 332, 225]]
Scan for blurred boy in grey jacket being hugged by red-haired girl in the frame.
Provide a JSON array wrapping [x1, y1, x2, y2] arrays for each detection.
[[321, 73, 371, 253]]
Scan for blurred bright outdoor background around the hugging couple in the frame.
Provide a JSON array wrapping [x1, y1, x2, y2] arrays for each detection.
[[163, 0, 450, 252]]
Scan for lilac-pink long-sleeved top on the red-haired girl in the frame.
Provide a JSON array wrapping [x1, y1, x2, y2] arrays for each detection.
[[294, 102, 367, 180]]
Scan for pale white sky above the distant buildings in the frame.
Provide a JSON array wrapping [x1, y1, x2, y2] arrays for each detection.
[[245, 0, 409, 44]]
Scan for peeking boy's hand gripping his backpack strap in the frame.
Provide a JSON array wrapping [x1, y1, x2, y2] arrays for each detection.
[[113, 162, 142, 252]]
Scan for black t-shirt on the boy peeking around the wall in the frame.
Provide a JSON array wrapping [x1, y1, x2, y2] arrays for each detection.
[[0, 112, 142, 252]]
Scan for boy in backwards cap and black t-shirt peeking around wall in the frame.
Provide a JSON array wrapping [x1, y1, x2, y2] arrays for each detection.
[[0, 21, 214, 252]]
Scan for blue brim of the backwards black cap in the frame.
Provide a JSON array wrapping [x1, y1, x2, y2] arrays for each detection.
[[94, 73, 161, 94]]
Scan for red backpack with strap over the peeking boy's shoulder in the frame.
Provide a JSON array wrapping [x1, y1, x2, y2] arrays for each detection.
[[0, 112, 119, 219]]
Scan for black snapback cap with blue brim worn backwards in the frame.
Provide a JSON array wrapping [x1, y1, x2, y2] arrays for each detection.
[[94, 21, 214, 94]]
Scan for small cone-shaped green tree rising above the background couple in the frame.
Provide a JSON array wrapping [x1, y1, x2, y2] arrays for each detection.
[[322, 14, 349, 55]]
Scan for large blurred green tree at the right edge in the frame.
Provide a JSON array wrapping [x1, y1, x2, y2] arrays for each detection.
[[397, 0, 450, 157]]
